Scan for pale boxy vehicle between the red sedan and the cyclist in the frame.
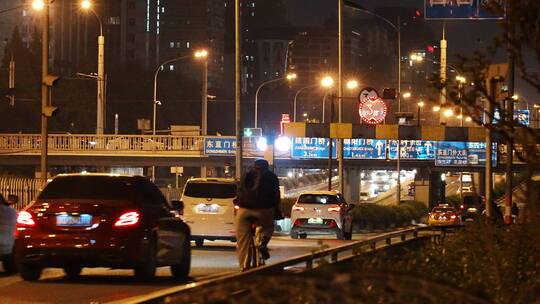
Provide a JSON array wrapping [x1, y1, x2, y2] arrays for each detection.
[[181, 178, 236, 246]]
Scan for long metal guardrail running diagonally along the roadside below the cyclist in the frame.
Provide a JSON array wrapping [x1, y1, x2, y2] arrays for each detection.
[[109, 226, 460, 304]]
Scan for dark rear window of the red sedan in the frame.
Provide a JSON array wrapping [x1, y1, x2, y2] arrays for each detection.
[[39, 176, 133, 200]]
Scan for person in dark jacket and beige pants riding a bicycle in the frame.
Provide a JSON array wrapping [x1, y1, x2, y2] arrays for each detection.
[[236, 159, 280, 271]]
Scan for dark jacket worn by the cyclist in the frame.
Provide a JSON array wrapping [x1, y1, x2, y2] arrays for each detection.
[[237, 166, 280, 209]]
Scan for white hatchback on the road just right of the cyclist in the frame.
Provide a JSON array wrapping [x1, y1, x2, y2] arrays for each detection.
[[291, 191, 354, 240]]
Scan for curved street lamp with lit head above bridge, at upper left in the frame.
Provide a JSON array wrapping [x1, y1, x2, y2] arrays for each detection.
[[81, 0, 105, 134]]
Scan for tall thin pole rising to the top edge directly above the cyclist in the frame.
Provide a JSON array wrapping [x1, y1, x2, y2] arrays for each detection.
[[234, 0, 243, 180]]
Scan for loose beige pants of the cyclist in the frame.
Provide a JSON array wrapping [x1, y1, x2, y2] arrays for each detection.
[[236, 208, 274, 271]]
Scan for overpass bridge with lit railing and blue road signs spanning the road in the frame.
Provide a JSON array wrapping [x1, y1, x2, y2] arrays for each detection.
[[0, 129, 524, 200]]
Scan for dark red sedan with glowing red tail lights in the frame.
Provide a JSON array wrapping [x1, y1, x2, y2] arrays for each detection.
[[15, 173, 191, 281]]
